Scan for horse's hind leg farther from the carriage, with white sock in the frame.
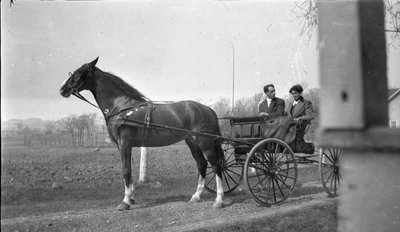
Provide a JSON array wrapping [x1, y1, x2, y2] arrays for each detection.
[[185, 138, 207, 202]]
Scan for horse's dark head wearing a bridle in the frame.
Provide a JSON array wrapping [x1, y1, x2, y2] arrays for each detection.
[[60, 57, 99, 97]]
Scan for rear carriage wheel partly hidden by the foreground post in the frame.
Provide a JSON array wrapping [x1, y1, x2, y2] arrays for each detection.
[[319, 148, 342, 197]]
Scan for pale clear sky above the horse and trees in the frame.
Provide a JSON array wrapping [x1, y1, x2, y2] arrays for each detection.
[[1, 0, 400, 121]]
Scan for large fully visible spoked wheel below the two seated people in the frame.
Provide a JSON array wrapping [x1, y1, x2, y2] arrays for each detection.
[[244, 139, 297, 206]]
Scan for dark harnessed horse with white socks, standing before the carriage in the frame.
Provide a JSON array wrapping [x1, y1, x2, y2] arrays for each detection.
[[60, 57, 224, 210]]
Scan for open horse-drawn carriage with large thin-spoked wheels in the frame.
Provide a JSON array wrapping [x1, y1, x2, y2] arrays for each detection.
[[205, 116, 342, 206]]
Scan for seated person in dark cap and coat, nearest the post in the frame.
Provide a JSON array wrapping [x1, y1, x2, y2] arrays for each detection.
[[288, 84, 314, 154]]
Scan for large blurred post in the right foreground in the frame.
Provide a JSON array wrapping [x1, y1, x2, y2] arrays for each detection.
[[317, 0, 400, 232]]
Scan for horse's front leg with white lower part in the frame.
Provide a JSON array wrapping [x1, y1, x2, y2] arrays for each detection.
[[117, 139, 135, 210]]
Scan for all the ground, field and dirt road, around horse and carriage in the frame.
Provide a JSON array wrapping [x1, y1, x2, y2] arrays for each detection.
[[1, 144, 337, 232]]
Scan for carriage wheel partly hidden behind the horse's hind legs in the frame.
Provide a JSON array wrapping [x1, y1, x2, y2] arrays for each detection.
[[205, 141, 243, 193]]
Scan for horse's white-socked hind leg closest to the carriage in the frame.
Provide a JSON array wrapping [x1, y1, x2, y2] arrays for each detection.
[[198, 137, 224, 209]]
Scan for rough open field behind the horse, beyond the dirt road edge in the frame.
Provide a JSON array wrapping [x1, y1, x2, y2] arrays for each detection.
[[1, 140, 335, 231]]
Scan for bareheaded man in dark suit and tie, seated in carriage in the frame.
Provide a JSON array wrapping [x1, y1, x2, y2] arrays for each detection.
[[258, 84, 285, 120]]
